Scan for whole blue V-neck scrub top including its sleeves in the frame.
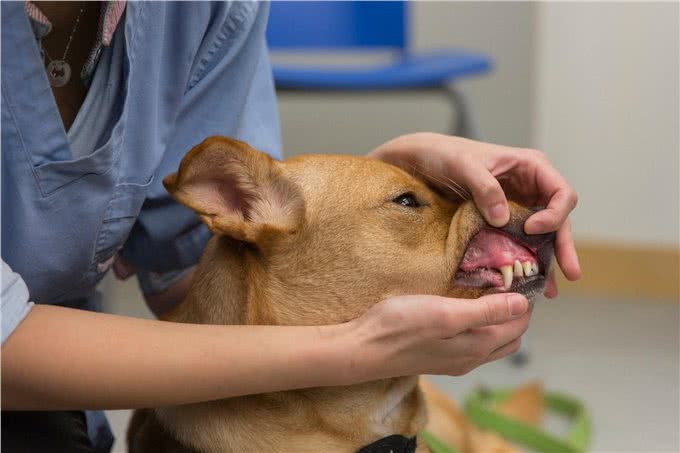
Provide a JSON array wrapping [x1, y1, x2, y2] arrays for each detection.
[[0, 2, 280, 448]]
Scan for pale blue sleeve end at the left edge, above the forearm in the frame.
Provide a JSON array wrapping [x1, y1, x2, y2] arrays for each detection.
[[0, 260, 33, 344]]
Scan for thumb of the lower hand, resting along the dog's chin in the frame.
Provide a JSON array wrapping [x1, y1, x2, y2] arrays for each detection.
[[448, 293, 529, 330]]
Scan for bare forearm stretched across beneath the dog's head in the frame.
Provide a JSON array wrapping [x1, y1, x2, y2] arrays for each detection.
[[2, 305, 346, 410]]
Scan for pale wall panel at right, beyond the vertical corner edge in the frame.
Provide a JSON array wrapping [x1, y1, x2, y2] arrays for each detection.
[[534, 3, 680, 246]]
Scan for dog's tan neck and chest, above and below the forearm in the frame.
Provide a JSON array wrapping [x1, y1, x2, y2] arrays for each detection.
[[157, 238, 425, 452]]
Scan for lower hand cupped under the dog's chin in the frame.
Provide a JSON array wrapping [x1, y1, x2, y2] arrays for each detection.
[[338, 293, 531, 383]]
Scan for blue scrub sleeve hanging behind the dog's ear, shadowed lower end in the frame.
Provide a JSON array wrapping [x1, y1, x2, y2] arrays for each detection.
[[121, 2, 281, 294]]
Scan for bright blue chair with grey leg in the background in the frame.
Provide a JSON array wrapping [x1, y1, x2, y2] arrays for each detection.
[[267, 1, 491, 138]]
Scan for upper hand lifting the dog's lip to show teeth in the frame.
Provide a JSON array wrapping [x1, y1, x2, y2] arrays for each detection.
[[369, 132, 581, 297]]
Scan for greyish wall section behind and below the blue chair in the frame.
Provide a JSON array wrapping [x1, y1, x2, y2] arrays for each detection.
[[280, 2, 536, 155]]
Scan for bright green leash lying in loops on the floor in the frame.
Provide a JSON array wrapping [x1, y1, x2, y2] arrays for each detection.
[[420, 390, 591, 453]]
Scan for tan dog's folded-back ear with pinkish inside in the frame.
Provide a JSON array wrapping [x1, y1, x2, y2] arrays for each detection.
[[163, 136, 304, 243]]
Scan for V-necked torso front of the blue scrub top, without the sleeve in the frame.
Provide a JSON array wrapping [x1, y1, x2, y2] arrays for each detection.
[[1, 2, 262, 303]]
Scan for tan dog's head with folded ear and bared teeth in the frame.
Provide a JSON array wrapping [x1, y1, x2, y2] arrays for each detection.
[[164, 137, 554, 325]]
